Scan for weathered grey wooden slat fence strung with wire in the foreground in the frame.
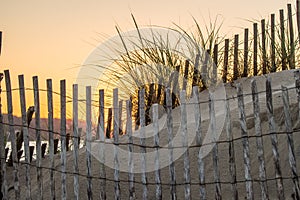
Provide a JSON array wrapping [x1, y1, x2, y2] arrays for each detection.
[[0, 70, 300, 199]]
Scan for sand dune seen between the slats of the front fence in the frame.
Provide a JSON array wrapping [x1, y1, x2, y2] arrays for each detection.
[[7, 70, 300, 199]]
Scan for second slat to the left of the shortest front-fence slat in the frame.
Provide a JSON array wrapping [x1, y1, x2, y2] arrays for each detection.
[[126, 100, 135, 200]]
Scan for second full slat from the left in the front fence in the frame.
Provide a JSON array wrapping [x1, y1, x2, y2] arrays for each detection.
[[19, 75, 31, 199]]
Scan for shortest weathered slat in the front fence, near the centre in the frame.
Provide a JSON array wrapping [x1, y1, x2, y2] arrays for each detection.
[[152, 104, 162, 199]]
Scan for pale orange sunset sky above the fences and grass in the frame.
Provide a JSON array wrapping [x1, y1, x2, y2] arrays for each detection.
[[0, 0, 296, 118]]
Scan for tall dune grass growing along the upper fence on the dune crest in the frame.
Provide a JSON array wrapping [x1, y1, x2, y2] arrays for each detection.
[[95, 5, 300, 130]]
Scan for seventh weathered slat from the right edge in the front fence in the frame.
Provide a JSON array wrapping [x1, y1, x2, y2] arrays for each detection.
[[209, 92, 222, 199]]
